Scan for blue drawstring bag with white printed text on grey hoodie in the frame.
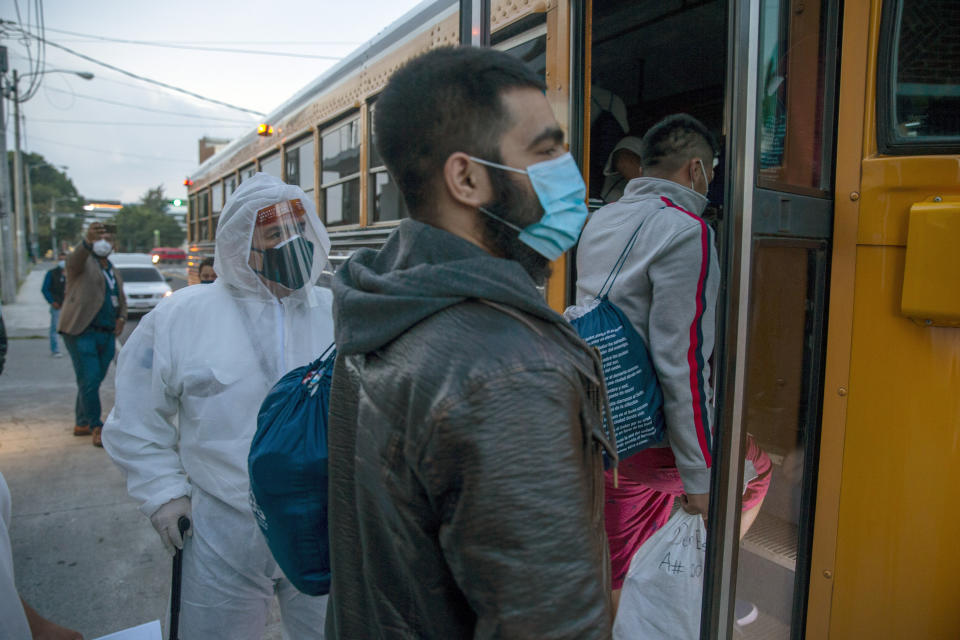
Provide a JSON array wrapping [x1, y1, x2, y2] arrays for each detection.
[[563, 224, 664, 460]]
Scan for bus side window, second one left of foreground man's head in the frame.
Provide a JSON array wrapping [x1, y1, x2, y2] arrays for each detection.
[[320, 118, 360, 225]]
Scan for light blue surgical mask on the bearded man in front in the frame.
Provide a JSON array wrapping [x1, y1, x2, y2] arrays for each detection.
[[470, 153, 587, 260]]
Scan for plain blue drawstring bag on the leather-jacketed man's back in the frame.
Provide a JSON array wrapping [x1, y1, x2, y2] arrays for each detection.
[[247, 345, 337, 596]]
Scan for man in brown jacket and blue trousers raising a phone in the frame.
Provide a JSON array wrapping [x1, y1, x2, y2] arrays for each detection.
[[57, 222, 127, 447]]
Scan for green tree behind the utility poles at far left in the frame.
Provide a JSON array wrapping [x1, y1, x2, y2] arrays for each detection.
[[7, 151, 84, 254]]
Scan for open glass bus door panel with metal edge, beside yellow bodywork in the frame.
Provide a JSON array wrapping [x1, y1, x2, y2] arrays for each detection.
[[702, 0, 839, 640]]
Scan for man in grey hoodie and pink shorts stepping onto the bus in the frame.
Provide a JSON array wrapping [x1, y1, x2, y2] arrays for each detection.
[[577, 114, 770, 615]]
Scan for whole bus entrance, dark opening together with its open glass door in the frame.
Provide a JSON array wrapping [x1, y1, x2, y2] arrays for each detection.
[[574, 0, 837, 640]]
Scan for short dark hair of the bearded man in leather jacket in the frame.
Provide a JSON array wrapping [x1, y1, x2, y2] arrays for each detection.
[[374, 47, 546, 218]]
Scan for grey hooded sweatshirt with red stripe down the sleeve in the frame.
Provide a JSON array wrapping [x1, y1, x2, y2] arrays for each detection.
[[577, 178, 720, 493]]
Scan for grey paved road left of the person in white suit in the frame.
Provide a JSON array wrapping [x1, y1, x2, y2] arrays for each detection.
[[0, 265, 280, 640]]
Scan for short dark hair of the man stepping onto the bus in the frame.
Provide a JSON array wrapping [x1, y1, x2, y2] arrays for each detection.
[[640, 113, 720, 175]]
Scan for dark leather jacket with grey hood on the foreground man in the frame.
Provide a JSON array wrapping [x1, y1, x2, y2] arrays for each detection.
[[327, 220, 611, 640]]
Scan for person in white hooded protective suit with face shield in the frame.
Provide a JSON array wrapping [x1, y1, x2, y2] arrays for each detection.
[[103, 173, 333, 640]]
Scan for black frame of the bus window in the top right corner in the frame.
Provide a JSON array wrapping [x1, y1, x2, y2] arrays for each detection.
[[876, 0, 960, 156]]
